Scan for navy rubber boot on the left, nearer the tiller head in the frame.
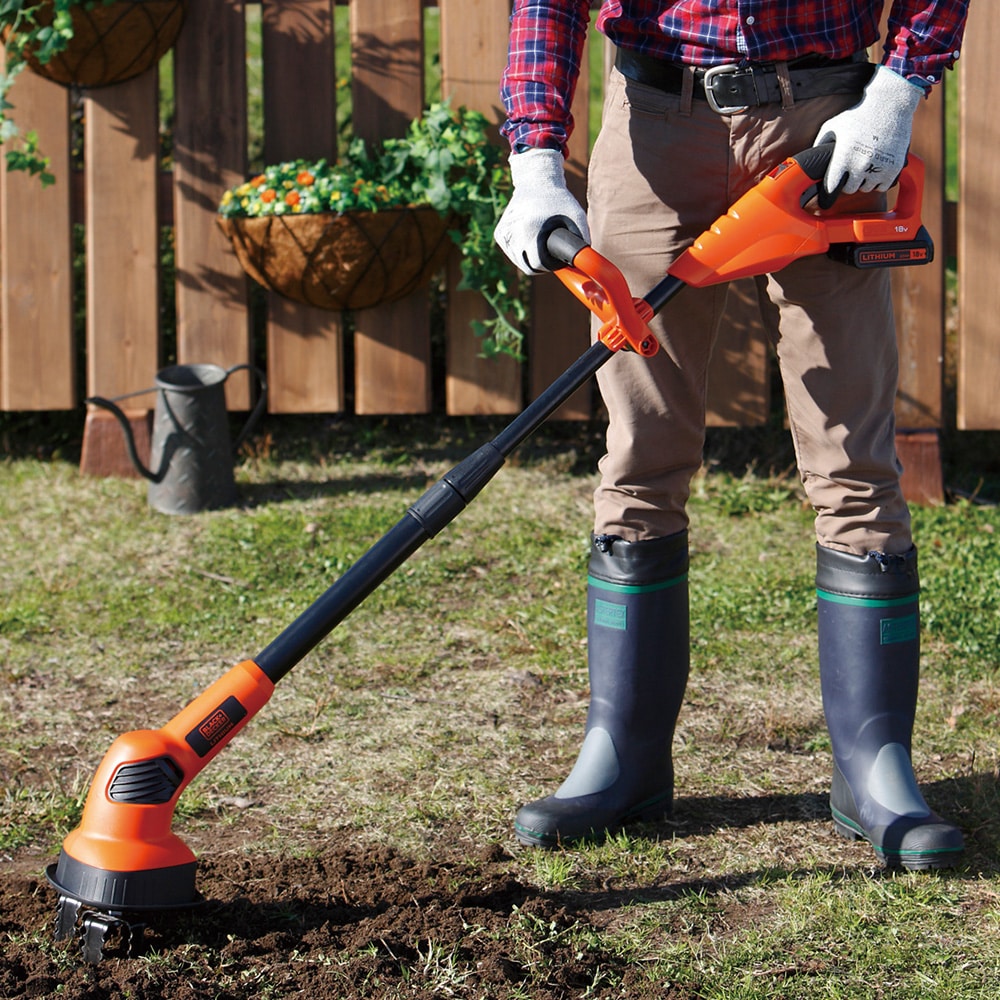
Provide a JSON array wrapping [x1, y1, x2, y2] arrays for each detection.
[[514, 532, 689, 847]]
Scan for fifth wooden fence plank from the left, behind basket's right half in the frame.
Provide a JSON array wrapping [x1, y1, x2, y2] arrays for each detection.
[[351, 0, 431, 414]]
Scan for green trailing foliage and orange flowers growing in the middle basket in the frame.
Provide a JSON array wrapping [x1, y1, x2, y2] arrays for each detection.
[[219, 102, 527, 358]]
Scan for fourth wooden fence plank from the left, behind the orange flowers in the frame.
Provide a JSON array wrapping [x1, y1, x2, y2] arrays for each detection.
[[263, 0, 344, 413]]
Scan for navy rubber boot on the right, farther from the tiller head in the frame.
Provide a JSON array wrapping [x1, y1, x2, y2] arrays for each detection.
[[816, 546, 964, 870]]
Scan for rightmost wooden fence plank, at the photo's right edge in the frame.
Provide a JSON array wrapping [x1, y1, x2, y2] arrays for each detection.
[[958, 12, 1000, 430]]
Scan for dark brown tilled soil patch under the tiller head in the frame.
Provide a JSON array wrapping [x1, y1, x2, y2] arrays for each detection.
[[0, 845, 676, 1000]]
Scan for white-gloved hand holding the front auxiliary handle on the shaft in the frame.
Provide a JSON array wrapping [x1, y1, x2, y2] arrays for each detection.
[[493, 149, 590, 274]]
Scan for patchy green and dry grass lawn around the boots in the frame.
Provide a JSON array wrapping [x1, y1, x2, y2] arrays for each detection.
[[0, 420, 1000, 1000]]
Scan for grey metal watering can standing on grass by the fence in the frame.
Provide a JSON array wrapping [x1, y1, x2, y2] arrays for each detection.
[[86, 364, 267, 514]]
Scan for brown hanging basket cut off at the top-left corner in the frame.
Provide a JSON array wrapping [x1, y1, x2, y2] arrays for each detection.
[[17, 0, 188, 87]]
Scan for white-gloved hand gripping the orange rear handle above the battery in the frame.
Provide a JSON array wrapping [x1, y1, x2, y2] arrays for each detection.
[[814, 66, 924, 194]]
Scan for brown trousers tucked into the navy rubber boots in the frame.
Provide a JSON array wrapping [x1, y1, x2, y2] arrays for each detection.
[[588, 70, 912, 555]]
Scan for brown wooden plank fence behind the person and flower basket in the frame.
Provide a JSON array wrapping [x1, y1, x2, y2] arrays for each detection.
[[0, 0, 1000, 499]]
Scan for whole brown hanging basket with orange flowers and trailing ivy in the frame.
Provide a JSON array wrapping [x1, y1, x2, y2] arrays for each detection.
[[218, 102, 527, 357]]
